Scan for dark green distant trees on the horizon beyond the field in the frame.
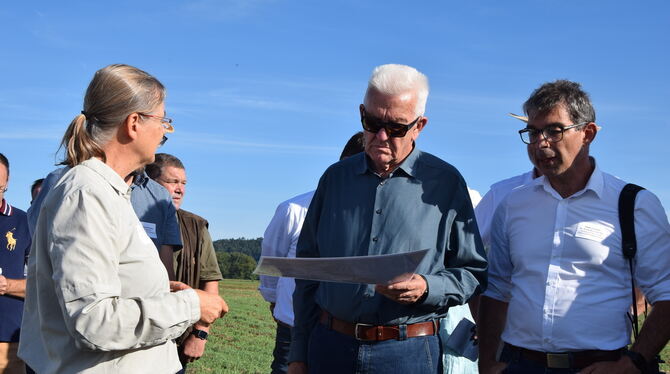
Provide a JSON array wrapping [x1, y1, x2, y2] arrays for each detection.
[[214, 238, 263, 279]]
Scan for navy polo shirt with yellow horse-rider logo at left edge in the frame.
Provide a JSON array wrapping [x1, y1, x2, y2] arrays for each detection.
[[0, 199, 30, 342]]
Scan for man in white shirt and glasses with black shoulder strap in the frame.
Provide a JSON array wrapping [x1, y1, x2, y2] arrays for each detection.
[[479, 80, 670, 374]]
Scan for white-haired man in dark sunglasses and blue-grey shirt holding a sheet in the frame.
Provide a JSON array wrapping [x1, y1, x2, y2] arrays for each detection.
[[289, 65, 487, 374]]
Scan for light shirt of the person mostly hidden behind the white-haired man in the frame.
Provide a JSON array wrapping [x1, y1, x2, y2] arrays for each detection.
[[258, 191, 314, 326]]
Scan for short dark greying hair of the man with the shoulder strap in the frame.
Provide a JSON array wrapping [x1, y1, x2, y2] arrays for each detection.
[[523, 79, 596, 123]]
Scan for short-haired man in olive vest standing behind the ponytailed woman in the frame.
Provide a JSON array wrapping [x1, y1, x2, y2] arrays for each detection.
[[146, 153, 222, 373]]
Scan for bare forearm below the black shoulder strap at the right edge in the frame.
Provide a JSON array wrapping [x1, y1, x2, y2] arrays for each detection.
[[631, 301, 670, 362]]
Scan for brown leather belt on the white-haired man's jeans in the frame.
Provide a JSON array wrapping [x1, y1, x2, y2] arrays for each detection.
[[319, 311, 440, 342]]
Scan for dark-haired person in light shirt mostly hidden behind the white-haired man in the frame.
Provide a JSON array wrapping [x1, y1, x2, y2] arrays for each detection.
[[258, 131, 365, 374]]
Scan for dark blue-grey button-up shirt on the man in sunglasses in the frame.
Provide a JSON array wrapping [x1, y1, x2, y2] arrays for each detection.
[[290, 149, 487, 361]]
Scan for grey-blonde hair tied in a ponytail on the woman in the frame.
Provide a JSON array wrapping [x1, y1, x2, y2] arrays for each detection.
[[61, 64, 165, 167]]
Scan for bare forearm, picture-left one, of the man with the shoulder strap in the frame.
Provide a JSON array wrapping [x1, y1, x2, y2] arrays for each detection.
[[477, 296, 508, 368]]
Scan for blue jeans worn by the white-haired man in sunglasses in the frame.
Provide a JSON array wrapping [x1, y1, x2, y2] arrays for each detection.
[[307, 323, 441, 374]]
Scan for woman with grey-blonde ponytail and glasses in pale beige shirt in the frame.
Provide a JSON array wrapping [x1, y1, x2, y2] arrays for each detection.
[[19, 65, 227, 374]]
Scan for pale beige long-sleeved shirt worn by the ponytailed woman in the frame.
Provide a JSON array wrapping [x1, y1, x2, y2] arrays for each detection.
[[19, 158, 200, 374]]
